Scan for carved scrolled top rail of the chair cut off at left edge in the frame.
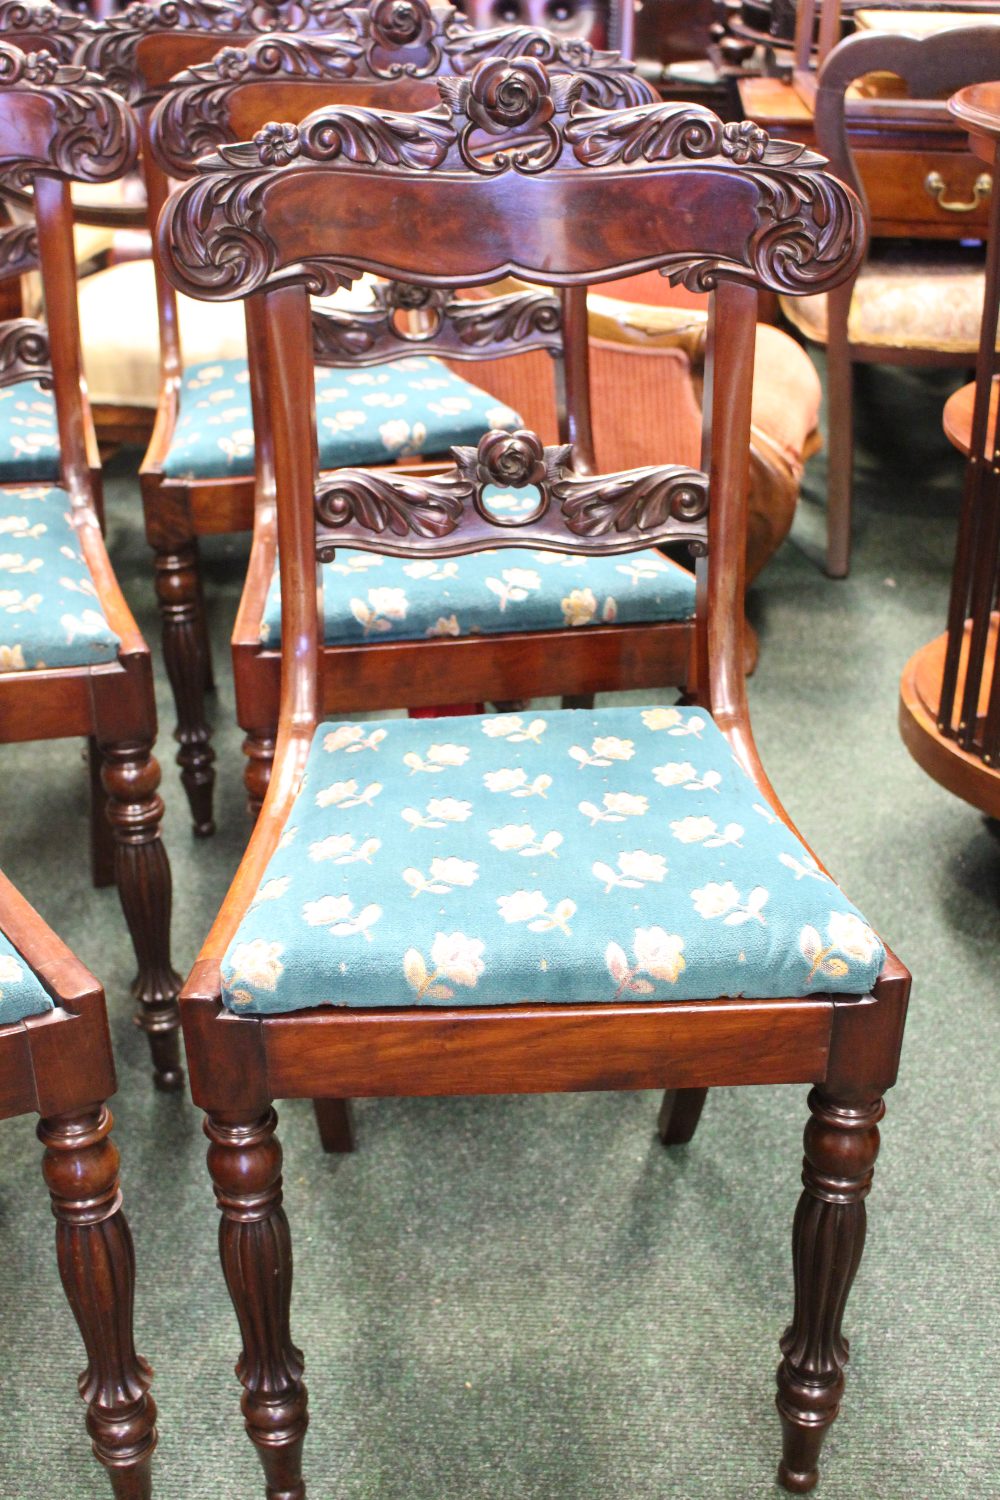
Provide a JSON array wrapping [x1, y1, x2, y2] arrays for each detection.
[[0, 42, 138, 188]]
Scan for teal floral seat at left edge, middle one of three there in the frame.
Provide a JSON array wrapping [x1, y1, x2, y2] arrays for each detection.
[[0, 486, 121, 672]]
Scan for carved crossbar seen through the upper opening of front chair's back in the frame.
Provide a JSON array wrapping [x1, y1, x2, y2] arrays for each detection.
[[312, 282, 562, 366]]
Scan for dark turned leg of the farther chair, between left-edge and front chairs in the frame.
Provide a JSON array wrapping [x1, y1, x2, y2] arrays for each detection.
[[154, 539, 216, 839]]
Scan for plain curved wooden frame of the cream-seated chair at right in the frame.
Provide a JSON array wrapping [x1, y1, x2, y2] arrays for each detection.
[[816, 27, 1000, 578]]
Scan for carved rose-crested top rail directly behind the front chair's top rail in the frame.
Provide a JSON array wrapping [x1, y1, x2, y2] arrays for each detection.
[[150, 0, 655, 177]]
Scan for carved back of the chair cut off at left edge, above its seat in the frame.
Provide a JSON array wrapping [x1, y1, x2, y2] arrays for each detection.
[[0, 42, 138, 507]]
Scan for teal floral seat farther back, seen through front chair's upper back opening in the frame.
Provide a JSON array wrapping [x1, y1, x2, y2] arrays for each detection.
[[163, 359, 520, 479]]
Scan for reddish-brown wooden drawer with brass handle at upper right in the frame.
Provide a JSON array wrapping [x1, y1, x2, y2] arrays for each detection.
[[855, 149, 990, 240]]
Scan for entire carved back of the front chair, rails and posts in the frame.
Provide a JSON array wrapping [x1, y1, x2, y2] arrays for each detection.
[[157, 59, 864, 744]]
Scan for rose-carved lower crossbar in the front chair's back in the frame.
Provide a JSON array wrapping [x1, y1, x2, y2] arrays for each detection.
[[315, 431, 708, 561]]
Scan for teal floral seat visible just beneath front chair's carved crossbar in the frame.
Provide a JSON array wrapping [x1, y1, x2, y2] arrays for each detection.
[[261, 548, 694, 647]]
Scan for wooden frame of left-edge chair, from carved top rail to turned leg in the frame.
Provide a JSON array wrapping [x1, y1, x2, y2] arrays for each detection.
[[0, 45, 183, 1089]]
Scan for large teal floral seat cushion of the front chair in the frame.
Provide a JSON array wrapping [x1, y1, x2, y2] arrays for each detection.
[[222, 707, 885, 1014]]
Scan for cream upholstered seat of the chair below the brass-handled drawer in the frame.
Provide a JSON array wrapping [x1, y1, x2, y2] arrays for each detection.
[[781, 245, 985, 356]]
